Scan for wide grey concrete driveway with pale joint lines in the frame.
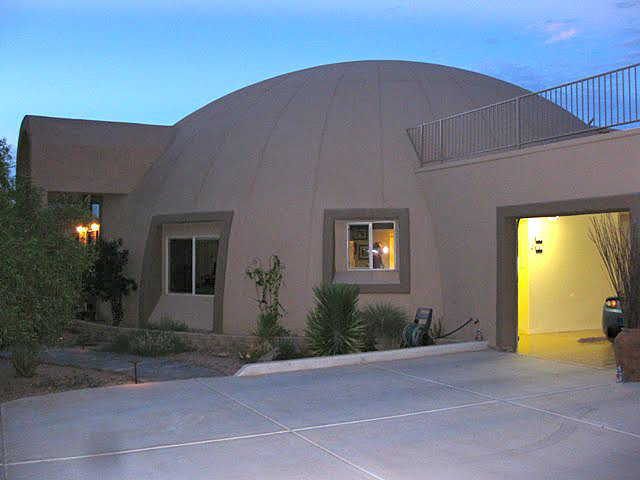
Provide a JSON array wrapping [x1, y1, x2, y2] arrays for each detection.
[[0, 351, 640, 480]]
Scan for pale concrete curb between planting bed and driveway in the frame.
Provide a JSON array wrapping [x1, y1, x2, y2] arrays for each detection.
[[235, 342, 489, 377]]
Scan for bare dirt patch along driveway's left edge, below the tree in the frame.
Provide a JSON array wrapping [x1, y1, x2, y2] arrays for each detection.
[[0, 358, 131, 403]]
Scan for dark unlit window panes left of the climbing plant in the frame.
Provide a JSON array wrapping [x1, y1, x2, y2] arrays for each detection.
[[167, 237, 218, 295]]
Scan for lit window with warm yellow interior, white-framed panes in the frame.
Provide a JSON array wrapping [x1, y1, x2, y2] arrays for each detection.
[[347, 221, 397, 270]]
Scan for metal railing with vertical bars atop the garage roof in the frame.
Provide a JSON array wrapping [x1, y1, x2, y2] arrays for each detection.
[[407, 63, 640, 166]]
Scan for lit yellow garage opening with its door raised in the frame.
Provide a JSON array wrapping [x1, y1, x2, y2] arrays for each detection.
[[517, 212, 629, 367]]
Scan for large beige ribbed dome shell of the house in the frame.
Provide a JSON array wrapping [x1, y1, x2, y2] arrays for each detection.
[[121, 61, 525, 333]]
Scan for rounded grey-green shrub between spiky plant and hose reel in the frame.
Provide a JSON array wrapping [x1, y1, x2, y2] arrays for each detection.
[[360, 303, 409, 350]]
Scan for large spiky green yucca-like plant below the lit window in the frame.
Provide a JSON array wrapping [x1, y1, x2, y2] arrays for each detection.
[[306, 283, 364, 356]]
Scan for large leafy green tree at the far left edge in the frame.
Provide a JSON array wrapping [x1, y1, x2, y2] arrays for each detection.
[[0, 139, 92, 375]]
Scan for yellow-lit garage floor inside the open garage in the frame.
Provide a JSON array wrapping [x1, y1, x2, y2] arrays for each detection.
[[518, 329, 616, 368]]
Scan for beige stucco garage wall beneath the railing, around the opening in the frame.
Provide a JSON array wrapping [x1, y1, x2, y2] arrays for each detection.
[[417, 129, 640, 344]]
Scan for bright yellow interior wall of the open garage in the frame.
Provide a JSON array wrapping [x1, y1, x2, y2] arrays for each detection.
[[518, 213, 618, 333]]
